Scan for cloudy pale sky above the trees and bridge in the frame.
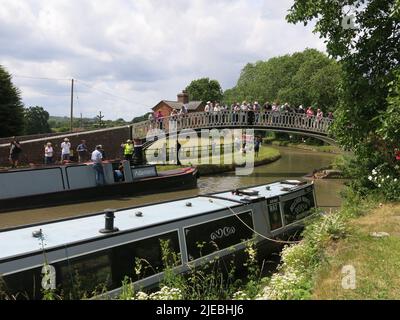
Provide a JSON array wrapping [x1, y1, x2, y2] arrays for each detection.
[[0, 0, 326, 121]]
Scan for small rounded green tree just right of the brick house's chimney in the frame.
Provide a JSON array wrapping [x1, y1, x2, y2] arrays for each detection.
[[185, 78, 223, 102]]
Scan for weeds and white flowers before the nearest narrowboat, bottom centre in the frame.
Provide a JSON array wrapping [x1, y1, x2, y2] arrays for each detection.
[[119, 241, 263, 300]]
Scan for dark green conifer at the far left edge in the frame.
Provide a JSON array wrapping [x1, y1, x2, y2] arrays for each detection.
[[0, 65, 24, 137]]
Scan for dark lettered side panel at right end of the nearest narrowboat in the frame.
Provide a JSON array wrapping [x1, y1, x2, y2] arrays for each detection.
[[282, 187, 315, 225]]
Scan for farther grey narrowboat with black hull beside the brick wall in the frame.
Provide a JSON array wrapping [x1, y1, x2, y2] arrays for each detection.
[[0, 161, 198, 212]]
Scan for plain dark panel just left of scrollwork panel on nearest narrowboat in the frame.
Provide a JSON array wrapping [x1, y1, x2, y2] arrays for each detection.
[[112, 231, 181, 286]]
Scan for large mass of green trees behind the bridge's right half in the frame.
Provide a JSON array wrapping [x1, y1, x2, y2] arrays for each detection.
[[224, 49, 341, 111]]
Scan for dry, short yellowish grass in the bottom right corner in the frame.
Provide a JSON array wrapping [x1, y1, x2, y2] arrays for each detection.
[[312, 204, 400, 300]]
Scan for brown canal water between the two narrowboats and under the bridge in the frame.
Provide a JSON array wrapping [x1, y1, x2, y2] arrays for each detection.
[[0, 147, 344, 228]]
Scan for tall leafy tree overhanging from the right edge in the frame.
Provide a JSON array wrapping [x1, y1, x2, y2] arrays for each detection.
[[286, 0, 400, 195]]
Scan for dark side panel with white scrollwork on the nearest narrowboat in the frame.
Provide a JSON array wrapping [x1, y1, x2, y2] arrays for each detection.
[[185, 212, 253, 260]]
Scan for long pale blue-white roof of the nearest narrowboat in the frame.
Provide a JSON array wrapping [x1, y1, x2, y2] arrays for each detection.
[[0, 180, 310, 260]]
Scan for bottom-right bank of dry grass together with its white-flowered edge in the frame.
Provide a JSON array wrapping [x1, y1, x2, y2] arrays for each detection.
[[262, 191, 400, 299]]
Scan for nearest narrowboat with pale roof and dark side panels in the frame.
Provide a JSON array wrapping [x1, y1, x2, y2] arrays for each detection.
[[0, 180, 316, 299]]
